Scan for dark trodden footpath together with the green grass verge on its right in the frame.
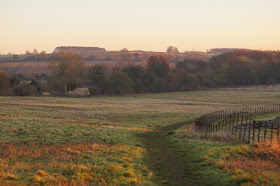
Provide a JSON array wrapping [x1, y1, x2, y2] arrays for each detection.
[[136, 120, 232, 185]]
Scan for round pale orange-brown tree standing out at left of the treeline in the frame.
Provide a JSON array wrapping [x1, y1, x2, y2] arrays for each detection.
[[49, 51, 87, 95]]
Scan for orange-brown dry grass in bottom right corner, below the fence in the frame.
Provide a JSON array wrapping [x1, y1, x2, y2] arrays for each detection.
[[204, 144, 280, 185]]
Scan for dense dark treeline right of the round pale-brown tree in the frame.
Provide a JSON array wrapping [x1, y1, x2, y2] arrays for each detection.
[[80, 50, 280, 94]]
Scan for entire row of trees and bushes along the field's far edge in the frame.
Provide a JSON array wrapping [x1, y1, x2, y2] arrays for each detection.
[[0, 50, 280, 95]]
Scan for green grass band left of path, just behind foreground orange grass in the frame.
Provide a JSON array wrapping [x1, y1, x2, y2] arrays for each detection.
[[0, 119, 141, 145]]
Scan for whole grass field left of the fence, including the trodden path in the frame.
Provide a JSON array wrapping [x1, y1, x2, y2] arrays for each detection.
[[0, 86, 280, 185]]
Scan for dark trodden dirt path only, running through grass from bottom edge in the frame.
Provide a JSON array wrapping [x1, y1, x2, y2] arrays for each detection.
[[138, 121, 229, 186]]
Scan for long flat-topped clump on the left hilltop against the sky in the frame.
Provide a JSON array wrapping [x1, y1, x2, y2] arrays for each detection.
[[54, 46, 107, 54]]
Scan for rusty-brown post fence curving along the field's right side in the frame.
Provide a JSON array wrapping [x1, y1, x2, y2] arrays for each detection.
[[195, 105, 280, 143]]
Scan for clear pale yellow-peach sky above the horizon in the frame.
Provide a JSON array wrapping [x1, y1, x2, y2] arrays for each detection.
[[0, 0, 280, 54]]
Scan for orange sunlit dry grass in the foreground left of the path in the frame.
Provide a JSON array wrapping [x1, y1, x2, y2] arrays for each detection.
[[0, 143, 151, 185]]
